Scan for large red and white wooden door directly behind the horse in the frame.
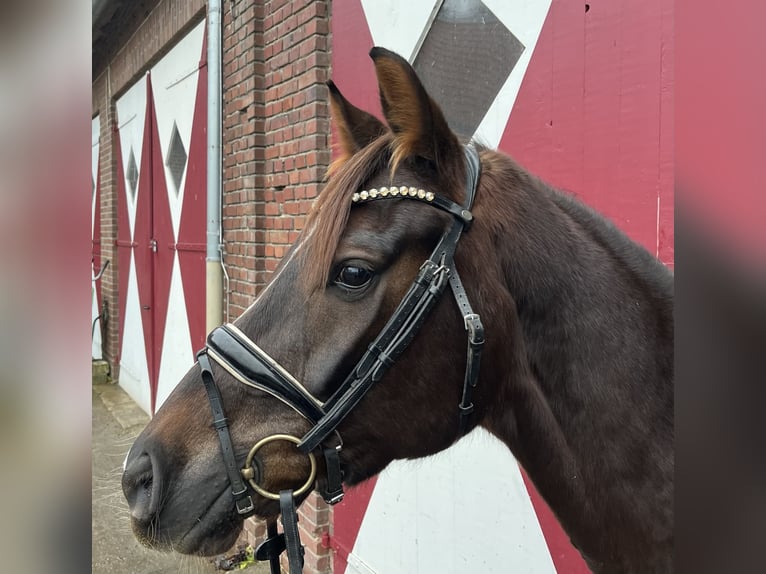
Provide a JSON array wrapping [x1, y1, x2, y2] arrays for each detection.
[[330, 0, 673, 574]]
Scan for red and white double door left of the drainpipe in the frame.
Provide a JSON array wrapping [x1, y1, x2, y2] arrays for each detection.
[[117, 22, 207, 413]]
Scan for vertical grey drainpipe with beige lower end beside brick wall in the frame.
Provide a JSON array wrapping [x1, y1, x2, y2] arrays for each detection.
[[205, 0, 224, 333]]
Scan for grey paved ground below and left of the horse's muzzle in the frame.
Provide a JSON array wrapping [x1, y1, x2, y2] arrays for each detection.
[[92, 384, 269, 574]]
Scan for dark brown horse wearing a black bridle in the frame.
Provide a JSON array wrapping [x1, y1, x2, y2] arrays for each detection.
[[122, 47, 674, 573]]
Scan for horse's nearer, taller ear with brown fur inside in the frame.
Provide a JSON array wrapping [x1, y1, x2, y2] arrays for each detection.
[[370, 46, 462, 177]]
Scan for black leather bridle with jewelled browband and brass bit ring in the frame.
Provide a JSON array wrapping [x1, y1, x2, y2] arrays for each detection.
[[197, 145, 484, 574]]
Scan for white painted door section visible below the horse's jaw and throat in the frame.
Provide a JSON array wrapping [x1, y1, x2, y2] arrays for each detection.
[[347, 429, 556, 574]]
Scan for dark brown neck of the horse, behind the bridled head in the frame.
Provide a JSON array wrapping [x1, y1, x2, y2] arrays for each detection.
[[476, 162, 672, 571]]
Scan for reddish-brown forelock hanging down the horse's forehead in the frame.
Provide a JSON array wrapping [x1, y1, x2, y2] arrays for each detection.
[[302, 132, 393, 293]]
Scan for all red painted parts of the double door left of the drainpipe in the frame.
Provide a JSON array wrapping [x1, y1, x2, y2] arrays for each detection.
[[116, 28, 207, 413]]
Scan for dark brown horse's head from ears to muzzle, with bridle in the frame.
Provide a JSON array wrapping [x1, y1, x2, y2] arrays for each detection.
[[123, 48, 503, 555]]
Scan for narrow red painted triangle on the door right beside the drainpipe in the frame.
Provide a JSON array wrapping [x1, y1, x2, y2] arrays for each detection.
[[175, 33, 207, 351]]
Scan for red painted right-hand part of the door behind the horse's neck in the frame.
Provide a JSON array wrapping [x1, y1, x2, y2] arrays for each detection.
[[500, 0, 673, 573]]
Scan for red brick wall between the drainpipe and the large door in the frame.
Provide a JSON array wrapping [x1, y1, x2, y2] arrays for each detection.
[[223, 0, 331, 573]]
